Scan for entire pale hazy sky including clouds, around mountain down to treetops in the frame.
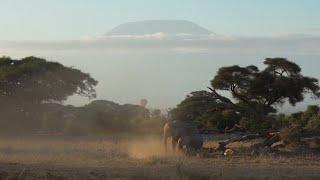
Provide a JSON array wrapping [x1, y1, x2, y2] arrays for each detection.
[[0, 0, 320, 112]]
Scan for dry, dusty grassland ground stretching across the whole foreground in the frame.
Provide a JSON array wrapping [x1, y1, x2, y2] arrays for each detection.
[[0, 134, 320, 179]]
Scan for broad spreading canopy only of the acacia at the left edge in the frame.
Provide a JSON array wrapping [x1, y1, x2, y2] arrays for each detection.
[[0, 57, 97, 103]]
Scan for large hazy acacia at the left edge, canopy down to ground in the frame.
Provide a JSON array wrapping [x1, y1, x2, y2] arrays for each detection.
[[0, 57, 98, 130]]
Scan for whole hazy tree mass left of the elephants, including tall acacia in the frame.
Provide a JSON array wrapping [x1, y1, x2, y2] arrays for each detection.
[[0, 57, 164, 135]]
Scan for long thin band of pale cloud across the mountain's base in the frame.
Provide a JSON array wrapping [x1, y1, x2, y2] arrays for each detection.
[[0, 32, 320, 55]]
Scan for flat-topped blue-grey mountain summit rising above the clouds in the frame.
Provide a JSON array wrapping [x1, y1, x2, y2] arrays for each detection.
[[106, 20, 211, 35]]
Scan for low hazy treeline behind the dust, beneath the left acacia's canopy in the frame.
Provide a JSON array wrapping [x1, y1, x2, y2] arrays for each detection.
[[0, 100, 165, 135]]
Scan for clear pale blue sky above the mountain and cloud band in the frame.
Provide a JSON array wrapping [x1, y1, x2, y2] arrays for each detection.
[[0, 0, 320, 40]]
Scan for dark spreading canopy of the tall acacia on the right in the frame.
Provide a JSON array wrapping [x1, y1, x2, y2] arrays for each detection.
[[211, 58, 319, 115]]
